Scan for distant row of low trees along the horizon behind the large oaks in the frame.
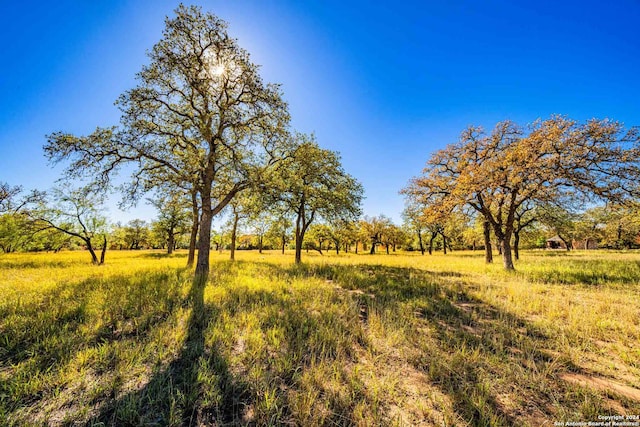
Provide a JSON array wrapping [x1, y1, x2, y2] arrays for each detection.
[[0, 177, 640, 263]]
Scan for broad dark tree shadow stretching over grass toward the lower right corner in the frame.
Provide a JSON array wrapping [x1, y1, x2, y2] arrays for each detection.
[[264, 265, 637, 426]]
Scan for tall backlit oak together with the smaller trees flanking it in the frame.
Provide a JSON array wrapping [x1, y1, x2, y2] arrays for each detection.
[[2, 5, 363, 283]]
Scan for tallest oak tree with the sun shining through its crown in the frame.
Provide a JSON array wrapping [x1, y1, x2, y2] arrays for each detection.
[[45, 6, 289, 283]]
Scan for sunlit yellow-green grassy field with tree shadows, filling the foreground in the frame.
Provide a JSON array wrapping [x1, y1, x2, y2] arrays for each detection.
[[0, 251, 640, 426]]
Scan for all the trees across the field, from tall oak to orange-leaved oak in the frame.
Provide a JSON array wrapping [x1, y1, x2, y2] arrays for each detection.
[[5, 6, 640, 283]]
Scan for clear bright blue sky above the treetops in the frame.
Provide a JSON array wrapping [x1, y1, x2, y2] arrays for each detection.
[[0, 0, 640, 221]]
